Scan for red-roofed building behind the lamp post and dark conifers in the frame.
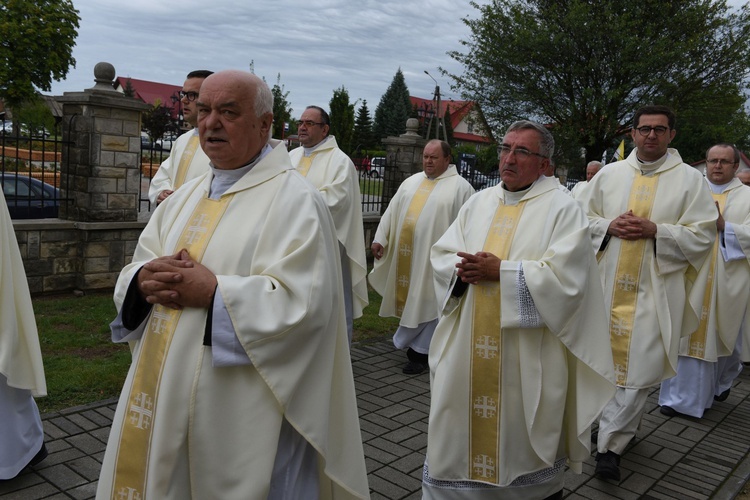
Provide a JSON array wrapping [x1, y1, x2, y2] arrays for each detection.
[[409, 96, 495, 147]]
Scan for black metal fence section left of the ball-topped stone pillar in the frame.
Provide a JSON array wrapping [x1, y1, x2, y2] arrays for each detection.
[[0, 123, 75, 219]]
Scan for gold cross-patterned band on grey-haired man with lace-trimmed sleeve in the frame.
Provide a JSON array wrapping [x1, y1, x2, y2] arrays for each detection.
[[469, 201, 526, 484]]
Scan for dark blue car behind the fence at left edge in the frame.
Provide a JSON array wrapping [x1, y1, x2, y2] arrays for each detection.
[[0, 172, 60, 219]]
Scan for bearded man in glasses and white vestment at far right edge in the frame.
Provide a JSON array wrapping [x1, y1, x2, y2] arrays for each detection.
[[659, 144, 750, 418]]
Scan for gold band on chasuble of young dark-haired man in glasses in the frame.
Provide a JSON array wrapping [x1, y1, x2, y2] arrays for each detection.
[[609, 174, 659, 386]]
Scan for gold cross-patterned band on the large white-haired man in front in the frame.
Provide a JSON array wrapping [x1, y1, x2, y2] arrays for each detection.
[[112, 195, 233, 499]]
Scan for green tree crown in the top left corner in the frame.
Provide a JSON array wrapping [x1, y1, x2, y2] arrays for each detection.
[[0, 0, 80, 109]]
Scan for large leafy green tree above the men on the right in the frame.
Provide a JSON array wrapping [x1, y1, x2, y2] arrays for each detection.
[[444, 0, 750, 162]]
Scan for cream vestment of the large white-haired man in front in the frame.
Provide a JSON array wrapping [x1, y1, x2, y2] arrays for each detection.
[[97, 141, 369, 500]]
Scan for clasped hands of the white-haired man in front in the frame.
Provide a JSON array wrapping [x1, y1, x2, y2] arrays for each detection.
[[137, 249, 218, 309]]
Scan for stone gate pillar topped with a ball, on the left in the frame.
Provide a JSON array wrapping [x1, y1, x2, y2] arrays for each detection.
[[56, 62, 148, 222]]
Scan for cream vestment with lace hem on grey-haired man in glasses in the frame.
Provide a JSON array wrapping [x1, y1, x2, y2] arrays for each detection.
[[423, 177, 614, 499]]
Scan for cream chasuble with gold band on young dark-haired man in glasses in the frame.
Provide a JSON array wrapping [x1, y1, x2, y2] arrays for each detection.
[[581, 149, 716, 389]]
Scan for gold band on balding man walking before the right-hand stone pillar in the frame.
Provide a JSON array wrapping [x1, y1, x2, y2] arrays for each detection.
[[396, 177, 437, 316]]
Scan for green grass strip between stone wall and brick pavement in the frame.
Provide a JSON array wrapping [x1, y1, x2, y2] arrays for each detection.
[[33, 289, 398, 413]]
